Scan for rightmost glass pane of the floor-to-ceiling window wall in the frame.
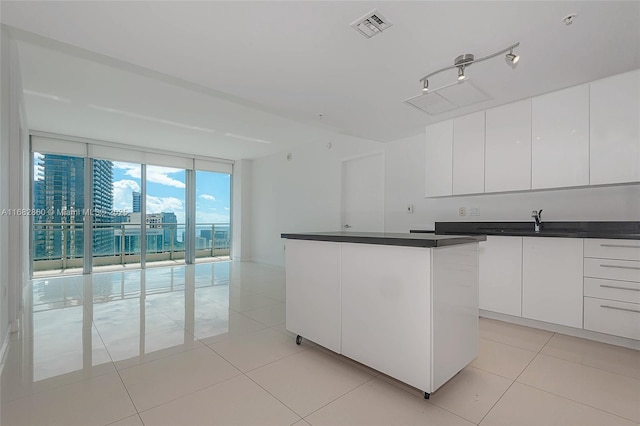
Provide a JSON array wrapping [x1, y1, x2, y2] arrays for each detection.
[[195, 170, 231, 258]]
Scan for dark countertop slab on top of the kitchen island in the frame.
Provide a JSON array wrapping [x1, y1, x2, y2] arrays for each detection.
[[281, 232, 487, 248]]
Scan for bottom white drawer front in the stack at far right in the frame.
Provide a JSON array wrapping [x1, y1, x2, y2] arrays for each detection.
[[584, 297, 640, 340]]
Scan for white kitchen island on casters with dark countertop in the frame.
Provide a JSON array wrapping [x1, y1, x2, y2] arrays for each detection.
[[282, 232, 486, 398]]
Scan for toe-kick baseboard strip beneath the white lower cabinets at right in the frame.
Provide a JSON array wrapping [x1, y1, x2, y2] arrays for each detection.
[[480, 309, 640, 350]]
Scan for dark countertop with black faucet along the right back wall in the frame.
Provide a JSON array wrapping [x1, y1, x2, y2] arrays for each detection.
[[411, 221, 640, 240]]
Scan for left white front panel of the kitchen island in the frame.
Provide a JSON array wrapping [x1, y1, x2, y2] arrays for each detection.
[[285, 240, 341, 353]]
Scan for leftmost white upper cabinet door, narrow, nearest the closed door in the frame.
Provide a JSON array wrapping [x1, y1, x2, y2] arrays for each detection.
[[425, 120, 453, 197]]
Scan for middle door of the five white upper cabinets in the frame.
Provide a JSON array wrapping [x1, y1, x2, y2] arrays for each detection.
[[485, 99, 531, 192]]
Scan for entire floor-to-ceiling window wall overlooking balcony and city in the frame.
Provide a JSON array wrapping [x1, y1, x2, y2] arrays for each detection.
[[30, 136, 232, 274]]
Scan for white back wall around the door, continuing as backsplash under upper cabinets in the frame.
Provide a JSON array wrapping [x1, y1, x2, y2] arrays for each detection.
[[251, 130, 640, 265]]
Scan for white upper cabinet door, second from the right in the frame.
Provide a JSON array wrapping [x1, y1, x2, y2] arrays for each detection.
[[531, 84, 589, 189]]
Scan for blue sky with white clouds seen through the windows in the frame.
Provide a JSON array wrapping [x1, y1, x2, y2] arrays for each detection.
[[113, 162, 231, 223]]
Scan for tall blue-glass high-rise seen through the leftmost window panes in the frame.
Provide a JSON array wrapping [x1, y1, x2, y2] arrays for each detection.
[[34, 154, 113, 258]]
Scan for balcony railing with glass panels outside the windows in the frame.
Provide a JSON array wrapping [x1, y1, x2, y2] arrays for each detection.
[[33, 223, 231, 271]]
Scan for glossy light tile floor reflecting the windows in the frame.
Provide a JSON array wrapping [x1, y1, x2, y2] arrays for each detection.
[[0, 262, 640, 426]]
